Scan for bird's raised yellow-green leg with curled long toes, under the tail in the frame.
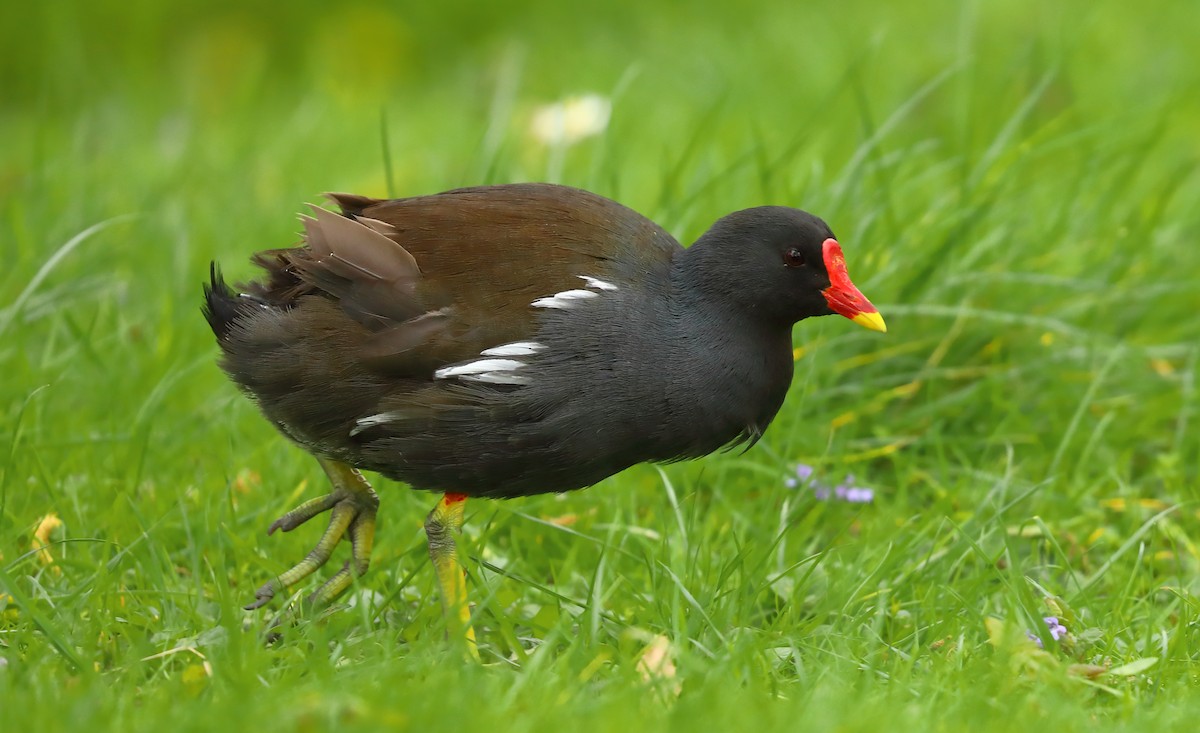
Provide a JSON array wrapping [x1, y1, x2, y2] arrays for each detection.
[[246, 458, 379, 611]]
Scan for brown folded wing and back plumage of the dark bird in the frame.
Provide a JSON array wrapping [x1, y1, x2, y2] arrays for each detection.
[[252, 184, 679, 377]]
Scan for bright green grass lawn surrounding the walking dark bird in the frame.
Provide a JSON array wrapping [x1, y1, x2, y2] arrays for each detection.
[[0, 0, 1200, 733]]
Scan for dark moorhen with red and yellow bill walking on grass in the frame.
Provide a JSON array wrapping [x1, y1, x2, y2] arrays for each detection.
[[202, 184, 887, 656]]
